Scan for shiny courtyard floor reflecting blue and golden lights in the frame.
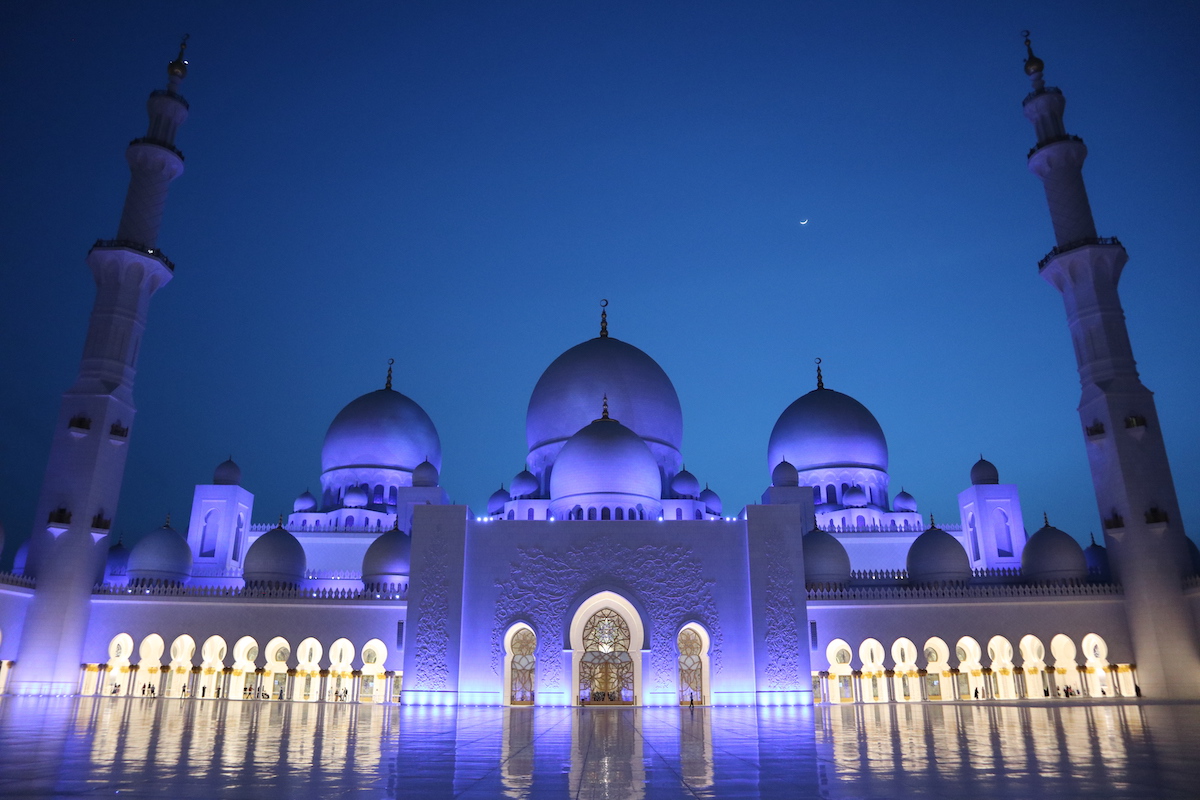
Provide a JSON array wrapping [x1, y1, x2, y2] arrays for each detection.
[[0, 697, 1200, 800]]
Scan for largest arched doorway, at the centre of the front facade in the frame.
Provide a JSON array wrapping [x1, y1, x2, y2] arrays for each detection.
[[570, 591, 646, 705]]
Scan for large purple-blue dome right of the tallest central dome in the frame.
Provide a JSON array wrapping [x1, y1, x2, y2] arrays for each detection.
[[767, 389, 888, 473]]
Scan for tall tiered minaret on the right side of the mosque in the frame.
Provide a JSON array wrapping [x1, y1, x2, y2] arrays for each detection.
[[1024, 38, 1200, 698]]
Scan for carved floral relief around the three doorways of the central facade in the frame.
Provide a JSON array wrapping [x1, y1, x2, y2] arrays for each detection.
[[492, 542, 724, 691]]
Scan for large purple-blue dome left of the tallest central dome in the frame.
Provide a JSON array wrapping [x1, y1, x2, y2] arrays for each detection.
[[320, 389, 442, 473]]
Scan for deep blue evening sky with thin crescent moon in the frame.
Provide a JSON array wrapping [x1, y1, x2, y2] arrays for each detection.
[[0, 1, 1200, 563]]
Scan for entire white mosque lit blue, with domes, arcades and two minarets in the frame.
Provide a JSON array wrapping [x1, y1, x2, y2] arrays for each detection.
[[0, 40, 1200, 705]]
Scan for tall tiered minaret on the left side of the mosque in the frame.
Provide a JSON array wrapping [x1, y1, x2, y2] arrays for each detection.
[[13, 43, 187, 694]]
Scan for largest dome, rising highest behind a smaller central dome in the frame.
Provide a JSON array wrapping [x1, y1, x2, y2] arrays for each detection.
[[526, 336, 683, 475]]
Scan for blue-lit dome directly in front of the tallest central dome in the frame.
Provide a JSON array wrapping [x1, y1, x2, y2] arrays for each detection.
[[550, 417, 662, 501]]
